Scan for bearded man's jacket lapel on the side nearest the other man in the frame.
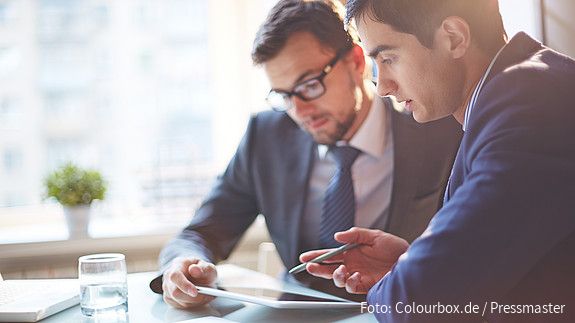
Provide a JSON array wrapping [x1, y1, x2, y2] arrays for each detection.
[[384, 103, 424, 234]]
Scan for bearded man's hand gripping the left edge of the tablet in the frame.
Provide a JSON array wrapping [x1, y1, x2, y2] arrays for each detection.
[[162, 257, 218, 309]]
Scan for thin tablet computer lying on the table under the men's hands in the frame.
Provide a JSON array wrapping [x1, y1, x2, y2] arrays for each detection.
[[197, 286, 361, 309]]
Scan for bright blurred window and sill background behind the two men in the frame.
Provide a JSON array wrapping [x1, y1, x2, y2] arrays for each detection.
[[0, 0, 575, 277]]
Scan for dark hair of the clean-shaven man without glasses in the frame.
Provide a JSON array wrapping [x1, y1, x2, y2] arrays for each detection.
[[345, 0, 506, 53]]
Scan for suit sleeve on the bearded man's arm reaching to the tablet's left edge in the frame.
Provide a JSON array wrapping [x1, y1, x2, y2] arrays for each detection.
[[151, 116, 259, 292]]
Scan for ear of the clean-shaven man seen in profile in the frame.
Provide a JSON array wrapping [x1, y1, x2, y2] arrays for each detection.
[[436, 16, 471, 59]]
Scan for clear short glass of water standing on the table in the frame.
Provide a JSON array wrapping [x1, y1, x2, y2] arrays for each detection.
[[78, 253, 128, 316]]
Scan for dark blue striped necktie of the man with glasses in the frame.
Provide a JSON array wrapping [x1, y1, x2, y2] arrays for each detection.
[[319, 146, 360, 248]]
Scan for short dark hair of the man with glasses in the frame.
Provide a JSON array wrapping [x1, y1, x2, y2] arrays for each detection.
[[252, 0, 357, 65]]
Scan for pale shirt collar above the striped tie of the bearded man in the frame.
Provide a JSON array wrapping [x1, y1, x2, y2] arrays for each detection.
[[317, 96, 388, 159]]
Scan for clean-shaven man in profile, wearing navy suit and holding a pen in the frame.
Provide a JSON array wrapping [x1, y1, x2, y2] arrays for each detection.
[[301, 0, 575, 322]]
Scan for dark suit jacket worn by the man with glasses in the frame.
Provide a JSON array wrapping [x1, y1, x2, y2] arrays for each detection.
[[151, 99, 462, 295]]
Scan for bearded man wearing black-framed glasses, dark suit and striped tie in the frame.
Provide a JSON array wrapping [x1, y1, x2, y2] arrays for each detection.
[[152, 0, 461, 308]]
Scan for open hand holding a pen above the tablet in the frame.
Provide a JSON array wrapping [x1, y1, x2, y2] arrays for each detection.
[[299, 228, 409, 294]]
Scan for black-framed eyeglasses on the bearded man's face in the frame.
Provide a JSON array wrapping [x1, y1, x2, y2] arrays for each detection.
[[266, 48, 350, 112]]
